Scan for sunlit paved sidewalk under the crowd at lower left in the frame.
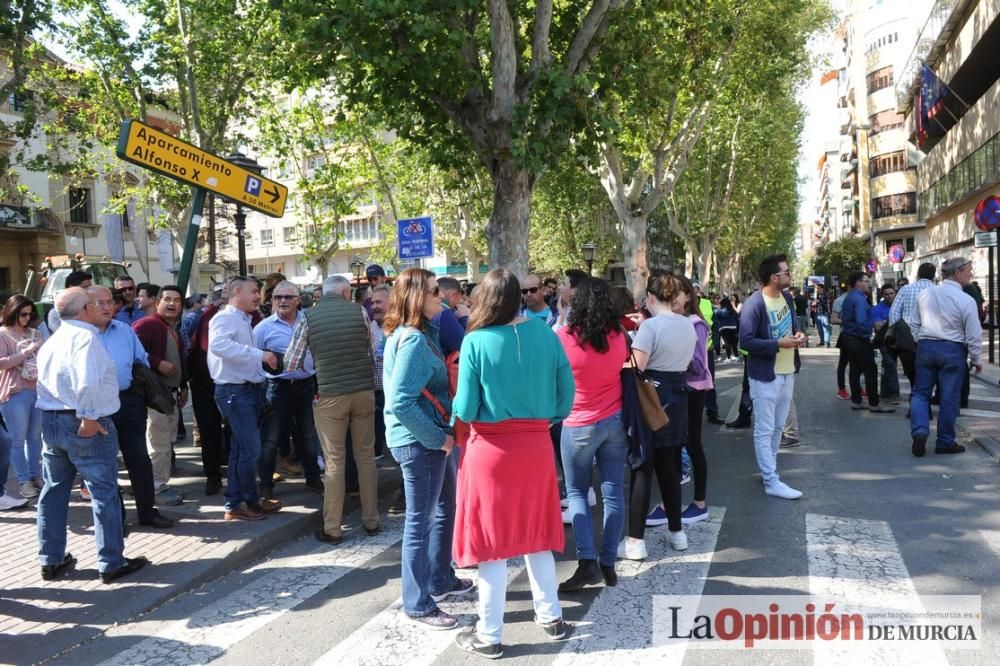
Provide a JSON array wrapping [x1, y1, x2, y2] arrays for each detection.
[[0, 425, 399, 664]]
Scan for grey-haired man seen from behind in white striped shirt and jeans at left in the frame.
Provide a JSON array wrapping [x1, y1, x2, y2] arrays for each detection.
[[36, 287, 148, 583]]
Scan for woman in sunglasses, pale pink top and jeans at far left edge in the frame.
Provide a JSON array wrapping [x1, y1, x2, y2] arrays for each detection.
[[0, 294, 42, 510]]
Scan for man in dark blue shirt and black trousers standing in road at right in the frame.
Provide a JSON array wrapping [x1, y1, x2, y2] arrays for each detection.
[[840, 271, 895, 413]]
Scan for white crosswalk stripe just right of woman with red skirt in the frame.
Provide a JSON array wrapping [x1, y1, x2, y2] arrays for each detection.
[[554, 507, 726, 666]]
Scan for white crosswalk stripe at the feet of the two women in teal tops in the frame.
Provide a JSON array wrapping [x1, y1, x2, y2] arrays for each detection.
[[315, 558, 524, 666]]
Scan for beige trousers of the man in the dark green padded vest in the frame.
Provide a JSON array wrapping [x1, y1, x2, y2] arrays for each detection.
[[313, 391, 378, 536]]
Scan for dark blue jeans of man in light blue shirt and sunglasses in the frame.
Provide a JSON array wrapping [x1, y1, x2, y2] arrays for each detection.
[[259, 378, 319, 488]]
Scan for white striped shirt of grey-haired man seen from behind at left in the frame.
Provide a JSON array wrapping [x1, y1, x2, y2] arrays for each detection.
[[35, 319, 121, 420]]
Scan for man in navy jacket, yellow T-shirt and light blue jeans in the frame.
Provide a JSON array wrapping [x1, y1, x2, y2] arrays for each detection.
[[740, 254, 806, 499]]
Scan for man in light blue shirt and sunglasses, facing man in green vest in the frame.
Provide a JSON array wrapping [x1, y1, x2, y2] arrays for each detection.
[[253, 281, 323, 499]]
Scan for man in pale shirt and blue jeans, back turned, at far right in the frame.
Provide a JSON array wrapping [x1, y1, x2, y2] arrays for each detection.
[[910, 257, 983, 458]]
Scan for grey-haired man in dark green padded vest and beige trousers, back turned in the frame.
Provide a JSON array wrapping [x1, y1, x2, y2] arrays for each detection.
[[285, 275, 379, 544]]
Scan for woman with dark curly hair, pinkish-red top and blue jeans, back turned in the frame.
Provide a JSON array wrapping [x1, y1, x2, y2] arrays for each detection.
[[558, 278, 628, 592]]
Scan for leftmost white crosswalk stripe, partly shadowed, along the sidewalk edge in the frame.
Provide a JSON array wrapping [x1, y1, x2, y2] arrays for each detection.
[[97, 518, 403, 666]]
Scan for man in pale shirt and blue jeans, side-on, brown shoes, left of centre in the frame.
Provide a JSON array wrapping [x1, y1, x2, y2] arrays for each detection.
[[207, 276, 281, 520]]
